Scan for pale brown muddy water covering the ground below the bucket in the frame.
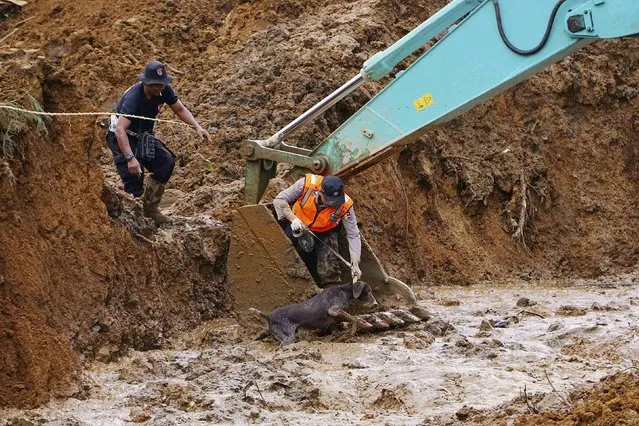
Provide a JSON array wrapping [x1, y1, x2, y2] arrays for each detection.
[[0, 276, 639, 425]]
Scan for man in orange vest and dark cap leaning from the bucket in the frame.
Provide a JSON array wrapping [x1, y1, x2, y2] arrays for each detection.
[[273, 174, 362, 287]]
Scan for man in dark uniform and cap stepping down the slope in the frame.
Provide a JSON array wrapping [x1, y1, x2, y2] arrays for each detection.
[[107, 61, 211, 225]]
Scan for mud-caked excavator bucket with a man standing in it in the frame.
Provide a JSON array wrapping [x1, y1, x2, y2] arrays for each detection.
[[227, 204, 416, 312]]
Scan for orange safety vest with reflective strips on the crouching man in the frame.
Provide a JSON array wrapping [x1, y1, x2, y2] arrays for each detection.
[[293, 173, 353, 232]]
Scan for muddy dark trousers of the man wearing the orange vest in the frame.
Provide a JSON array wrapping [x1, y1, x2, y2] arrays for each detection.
[[282, 220, 340, 287]]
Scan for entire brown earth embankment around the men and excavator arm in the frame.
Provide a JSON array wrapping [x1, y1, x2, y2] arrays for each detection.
[[0, 0, 639, 424]]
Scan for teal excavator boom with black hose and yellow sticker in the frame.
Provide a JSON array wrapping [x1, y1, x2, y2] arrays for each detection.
[[231, 0, 639, 312]]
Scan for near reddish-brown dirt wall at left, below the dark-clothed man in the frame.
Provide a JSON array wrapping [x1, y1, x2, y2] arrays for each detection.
[[0, 57, 228, 406]]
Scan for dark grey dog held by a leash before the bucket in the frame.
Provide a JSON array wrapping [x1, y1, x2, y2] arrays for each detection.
[[250, 281, 377, 346]]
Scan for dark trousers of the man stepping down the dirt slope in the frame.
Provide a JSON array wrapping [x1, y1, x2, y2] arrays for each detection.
[[106, 132, 175, 197]]
